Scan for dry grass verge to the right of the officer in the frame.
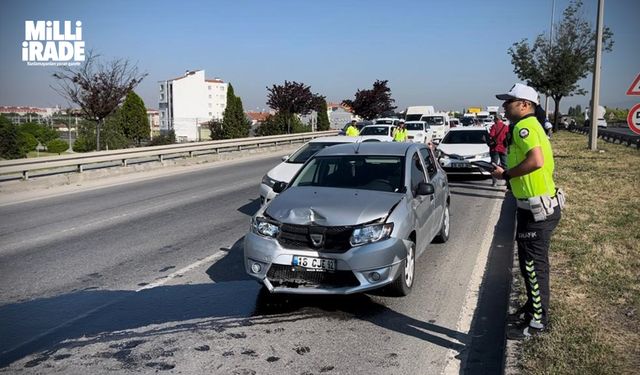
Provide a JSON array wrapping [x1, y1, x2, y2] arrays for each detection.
[[520, 132, 640, 374]]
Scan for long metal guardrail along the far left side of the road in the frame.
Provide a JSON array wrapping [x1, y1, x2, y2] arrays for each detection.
[[0, 130, 338, 180]]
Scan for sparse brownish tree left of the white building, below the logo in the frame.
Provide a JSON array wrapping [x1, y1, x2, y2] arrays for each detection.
[[52, 51, 147, 151]]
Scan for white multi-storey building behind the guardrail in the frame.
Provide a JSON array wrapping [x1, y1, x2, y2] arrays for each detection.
[[158, 70, 229, 142]]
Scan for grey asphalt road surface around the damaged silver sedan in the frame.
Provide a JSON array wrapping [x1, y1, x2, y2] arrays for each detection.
[[0, 157, 513, 374]]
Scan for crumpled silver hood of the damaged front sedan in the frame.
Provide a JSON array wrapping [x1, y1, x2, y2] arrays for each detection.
[[265, 186, 404, 226]]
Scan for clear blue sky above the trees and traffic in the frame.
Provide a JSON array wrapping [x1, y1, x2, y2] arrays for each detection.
[[0, 0, 640, 110]]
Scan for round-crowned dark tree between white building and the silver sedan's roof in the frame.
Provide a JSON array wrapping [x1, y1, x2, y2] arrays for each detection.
[[261, 81, 315, 134]]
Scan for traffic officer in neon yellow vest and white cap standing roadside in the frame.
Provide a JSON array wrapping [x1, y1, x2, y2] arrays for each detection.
[[492, 83, 564, 340]]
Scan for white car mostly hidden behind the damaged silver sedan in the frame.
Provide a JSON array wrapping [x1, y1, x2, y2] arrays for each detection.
[[260, 135, 359, 205]]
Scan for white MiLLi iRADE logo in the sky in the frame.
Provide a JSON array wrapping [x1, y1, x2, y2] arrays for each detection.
[[22, 21, 84, 66]]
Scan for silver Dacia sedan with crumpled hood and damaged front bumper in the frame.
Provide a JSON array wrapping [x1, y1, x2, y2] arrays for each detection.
[[244, 142, 450, 296]]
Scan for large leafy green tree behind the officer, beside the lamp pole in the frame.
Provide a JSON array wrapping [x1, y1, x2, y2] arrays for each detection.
[[508, 0, 613, 130]]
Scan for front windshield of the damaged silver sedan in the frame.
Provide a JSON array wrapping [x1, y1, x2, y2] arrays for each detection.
[[291, 155, 404, 192]]
